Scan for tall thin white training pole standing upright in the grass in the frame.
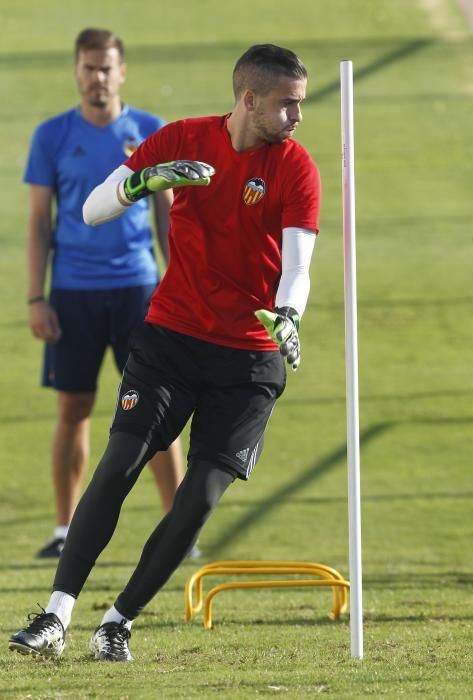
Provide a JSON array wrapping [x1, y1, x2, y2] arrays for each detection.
[[340, 61, 363, 658]]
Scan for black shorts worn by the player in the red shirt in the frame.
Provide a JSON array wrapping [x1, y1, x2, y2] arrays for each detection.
[[111, 323, 286, 479]]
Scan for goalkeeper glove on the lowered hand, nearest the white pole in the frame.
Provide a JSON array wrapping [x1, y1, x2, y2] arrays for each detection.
[[255, 306, 301, 371]]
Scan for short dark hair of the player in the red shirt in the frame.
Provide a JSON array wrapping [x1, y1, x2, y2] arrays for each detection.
[[233, 44, 307, 99]]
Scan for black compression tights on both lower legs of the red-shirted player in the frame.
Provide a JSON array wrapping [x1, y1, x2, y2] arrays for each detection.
[[54, 433, 235, 619]]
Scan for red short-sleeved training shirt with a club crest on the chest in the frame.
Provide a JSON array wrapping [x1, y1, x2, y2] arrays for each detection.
[[125, 115, 320, 350]]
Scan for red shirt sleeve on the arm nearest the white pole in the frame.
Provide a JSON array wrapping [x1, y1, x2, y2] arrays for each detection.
[[281, 145, 321, 233]]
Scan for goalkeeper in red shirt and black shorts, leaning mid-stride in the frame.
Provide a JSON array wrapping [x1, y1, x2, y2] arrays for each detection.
[[9, 44, 320, 661]]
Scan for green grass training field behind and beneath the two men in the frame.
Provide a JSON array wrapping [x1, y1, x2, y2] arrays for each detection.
[[0, 0, 473, 700]]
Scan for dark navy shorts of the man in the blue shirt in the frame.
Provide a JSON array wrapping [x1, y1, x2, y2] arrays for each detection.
[[42, 284, 155, 393]]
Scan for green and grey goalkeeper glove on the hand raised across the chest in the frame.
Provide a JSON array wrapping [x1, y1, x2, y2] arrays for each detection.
[[123, 160, 215, 202]]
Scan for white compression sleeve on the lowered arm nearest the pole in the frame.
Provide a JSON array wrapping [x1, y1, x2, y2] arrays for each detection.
[[276, 226, 315, 316]]
